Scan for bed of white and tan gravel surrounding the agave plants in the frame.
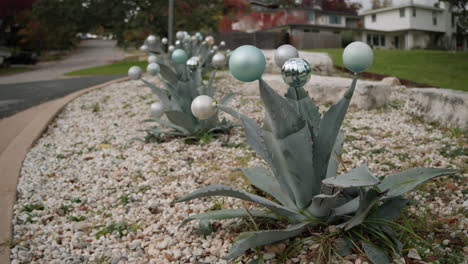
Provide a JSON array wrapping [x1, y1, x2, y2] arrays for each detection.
[[11, 72, 468, 264]]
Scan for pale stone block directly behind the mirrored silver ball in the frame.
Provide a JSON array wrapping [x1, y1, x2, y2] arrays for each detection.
[[262, 50, 334, 76]]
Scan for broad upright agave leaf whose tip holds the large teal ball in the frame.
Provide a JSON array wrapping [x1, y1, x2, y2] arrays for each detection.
[[259, 79, 310, 139]]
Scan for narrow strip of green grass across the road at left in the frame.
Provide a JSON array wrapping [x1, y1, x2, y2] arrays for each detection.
[[65, 57, 148, 76]]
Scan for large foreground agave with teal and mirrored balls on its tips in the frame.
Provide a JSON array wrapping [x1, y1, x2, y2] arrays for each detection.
[[177, 42, 458, 264]]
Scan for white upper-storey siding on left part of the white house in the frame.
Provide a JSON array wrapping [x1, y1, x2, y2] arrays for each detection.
[[364, 8, 411, 31]]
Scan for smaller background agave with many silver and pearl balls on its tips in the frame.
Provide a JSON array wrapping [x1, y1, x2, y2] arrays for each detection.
[[128, 32, 233, 138]]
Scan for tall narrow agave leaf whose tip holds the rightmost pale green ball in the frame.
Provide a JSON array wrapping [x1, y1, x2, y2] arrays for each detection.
[[314, 75, 357, 179]]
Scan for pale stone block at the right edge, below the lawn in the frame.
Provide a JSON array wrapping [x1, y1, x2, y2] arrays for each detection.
[[406, 88, 468, 132]]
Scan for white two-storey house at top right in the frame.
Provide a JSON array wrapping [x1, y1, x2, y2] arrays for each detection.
[[359, 2, 460, 49]]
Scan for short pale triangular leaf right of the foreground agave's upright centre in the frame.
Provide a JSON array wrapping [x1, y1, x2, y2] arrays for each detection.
[[322, 164, 380, 188]]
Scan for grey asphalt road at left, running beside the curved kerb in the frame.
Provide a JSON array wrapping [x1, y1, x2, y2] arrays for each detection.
[[0, 40, 125, 118]]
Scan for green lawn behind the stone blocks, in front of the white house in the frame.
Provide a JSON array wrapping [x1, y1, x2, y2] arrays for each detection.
[[308, 49, 468, 91]]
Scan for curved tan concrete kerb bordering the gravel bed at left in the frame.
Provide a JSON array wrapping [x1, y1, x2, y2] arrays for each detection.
[[0, 77, 128, 264]]
